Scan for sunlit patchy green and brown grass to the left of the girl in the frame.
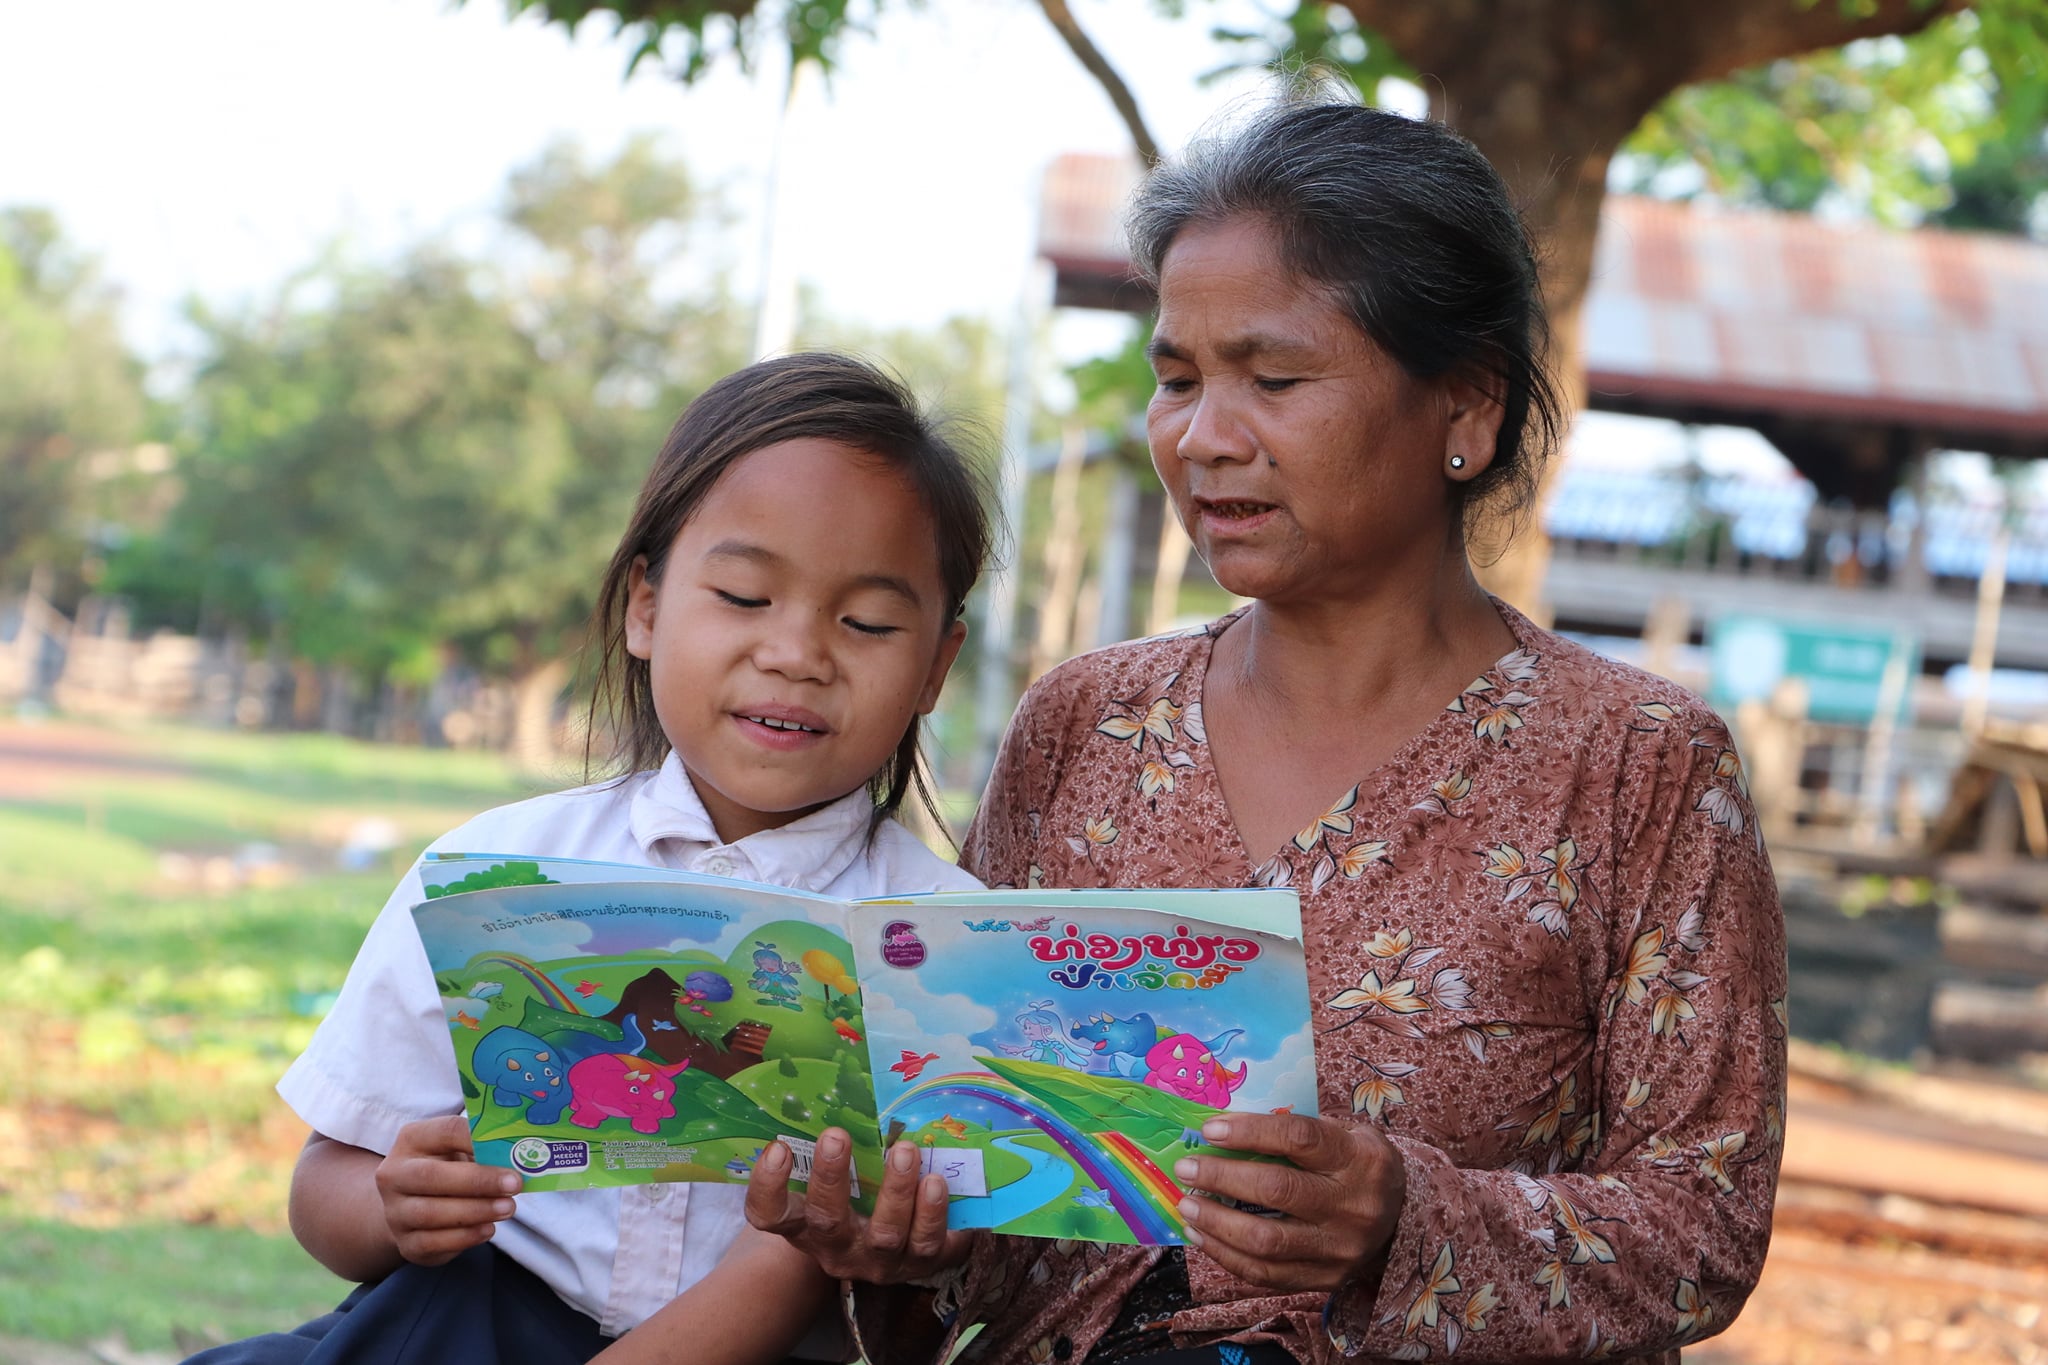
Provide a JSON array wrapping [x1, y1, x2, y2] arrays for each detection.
[[0, 718, 532, 1351]]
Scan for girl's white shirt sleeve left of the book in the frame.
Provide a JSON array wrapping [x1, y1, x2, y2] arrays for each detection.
[[276, 864, 463, 1152]]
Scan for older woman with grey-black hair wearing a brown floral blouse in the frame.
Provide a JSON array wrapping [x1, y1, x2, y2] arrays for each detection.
[[750, 100, 1786, 1365]]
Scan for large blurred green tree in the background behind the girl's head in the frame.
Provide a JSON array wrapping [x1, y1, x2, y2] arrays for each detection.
[[113, 139, 743, 724]]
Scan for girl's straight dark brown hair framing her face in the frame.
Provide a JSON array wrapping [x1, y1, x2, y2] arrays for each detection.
[[584, 352, 993, 837]]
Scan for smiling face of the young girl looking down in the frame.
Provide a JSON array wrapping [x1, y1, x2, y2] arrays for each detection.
[[627, 438, 967, 843]]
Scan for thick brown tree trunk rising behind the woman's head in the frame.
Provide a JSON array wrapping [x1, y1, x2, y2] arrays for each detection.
[[1343, 0, 1962, 612]]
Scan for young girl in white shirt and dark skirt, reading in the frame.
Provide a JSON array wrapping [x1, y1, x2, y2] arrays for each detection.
[[203, 354, 989, 1365]]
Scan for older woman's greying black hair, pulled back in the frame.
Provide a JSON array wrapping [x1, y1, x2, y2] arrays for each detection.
[[1124, 80, 1565, 544]]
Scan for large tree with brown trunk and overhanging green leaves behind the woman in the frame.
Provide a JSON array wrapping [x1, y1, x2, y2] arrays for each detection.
[[491, 0, 2048, 602]]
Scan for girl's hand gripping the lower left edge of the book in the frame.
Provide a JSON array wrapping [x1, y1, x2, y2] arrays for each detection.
[[377, 1113, 524, 1265]]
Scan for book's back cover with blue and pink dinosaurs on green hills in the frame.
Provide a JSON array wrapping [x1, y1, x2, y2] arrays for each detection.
[[414, 871, 881, 1193]]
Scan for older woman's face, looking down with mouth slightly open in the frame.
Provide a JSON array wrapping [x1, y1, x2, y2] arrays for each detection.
[[1147, 219, 1497, 602]]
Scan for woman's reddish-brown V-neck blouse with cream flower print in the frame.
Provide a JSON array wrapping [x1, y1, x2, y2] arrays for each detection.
[[852, 606, 1786, 1365]]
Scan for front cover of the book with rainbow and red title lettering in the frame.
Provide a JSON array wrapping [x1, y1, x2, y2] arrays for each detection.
[[850, 892, 1317, 1246]]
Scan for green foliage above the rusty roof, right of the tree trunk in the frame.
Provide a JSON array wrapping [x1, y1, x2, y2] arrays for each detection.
[[1616, 0, 2048, 231]]
